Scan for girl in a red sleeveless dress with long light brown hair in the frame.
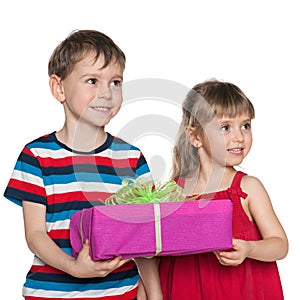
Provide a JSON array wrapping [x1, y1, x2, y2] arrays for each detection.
[[160, 80, 288, 300]]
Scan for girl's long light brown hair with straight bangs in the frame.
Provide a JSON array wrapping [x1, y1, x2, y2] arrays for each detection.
[[171, 79, 255, 179]]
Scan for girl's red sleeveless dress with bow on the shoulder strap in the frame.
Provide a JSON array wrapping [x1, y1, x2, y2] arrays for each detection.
[[159, 172, 283, 300]]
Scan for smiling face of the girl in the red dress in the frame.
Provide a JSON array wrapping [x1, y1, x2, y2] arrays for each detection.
[[201, 113, 252, 166]]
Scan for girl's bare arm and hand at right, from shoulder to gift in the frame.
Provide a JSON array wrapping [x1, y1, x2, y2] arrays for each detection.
[[216, 176, 288, 265]]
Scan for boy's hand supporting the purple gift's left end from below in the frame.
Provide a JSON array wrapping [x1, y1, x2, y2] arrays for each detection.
[[72, 240, 129, 278]]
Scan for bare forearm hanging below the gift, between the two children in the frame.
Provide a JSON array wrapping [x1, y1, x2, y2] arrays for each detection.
[[134, 257, 163, 300]]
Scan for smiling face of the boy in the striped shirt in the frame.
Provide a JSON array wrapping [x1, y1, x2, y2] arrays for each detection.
[[61, 53, 123, 127]]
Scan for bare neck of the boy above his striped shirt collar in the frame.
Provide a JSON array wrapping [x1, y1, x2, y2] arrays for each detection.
[[56, 126, 107, 152]]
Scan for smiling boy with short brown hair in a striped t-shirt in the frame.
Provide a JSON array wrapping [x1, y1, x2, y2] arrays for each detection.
[[4, 30, 161, 300]]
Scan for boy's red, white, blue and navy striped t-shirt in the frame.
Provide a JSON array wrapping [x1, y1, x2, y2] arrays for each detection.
[[4, 132, 150, 300]]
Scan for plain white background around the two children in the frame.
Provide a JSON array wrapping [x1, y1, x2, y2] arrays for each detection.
[[0, 0, 300, 300]]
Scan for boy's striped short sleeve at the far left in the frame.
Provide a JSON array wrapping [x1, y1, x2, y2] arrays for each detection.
[[4, 147, 47, 206]]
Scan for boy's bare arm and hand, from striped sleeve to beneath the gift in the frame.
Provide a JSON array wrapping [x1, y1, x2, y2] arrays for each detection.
[[23, 201, 126, 278]]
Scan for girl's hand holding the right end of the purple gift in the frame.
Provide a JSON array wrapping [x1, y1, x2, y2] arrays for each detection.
[[214, 239, 248, 266]]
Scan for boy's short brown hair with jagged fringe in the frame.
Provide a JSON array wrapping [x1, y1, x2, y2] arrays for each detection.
[[48, 30, 126, 80]]
